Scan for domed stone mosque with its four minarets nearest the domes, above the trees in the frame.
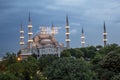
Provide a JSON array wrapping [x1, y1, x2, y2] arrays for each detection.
[[20, 14, 70, 59]]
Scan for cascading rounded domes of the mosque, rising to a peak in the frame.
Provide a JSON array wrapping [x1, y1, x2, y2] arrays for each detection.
[[33, 27, 63, 48]]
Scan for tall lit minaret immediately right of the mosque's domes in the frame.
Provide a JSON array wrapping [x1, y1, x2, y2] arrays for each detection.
[[65, 16, 70, 49]]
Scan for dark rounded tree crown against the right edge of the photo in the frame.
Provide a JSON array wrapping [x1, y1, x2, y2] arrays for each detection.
[[100, 51, 120, 72]]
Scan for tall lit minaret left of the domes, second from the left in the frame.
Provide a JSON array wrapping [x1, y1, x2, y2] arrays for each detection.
[[28, 13, 33, 49]]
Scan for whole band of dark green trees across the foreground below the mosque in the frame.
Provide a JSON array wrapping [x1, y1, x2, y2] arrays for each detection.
[[0, 44, 120, 80]]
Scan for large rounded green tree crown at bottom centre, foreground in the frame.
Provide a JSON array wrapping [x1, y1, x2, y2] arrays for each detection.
[[44, 58, 96, 80]]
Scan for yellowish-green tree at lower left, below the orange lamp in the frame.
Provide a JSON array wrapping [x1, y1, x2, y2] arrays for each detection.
[[6, 56, 38, 80]]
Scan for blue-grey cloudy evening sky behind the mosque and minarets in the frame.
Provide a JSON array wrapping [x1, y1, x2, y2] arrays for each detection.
[[0, 0, 120, 55]]
